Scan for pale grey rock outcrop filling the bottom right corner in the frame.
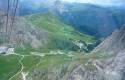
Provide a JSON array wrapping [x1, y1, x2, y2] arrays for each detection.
[[105, 50, 125, 80]]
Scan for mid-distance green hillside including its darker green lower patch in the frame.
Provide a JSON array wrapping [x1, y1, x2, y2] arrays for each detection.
[[26, 13, 94, 49]]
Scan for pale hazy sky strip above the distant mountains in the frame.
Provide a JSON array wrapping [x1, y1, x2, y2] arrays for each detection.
[[0, 0, 125, 5]]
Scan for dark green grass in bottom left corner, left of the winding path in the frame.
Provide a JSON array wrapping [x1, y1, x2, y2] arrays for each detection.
[[0, 55, 21, 80]]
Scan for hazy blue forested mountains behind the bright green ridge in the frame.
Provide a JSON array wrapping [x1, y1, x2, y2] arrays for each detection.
[[20, 1, 125, 38]]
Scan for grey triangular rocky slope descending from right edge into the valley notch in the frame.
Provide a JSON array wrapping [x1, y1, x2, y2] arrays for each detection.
[[93, 27, 125, 54]]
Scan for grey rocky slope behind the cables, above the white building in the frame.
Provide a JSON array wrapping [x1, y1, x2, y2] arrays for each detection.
[[0, 12, 48, 48]]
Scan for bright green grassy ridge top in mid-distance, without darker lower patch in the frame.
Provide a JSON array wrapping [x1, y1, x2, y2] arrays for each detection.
[[27, 13, 93, 42]]
